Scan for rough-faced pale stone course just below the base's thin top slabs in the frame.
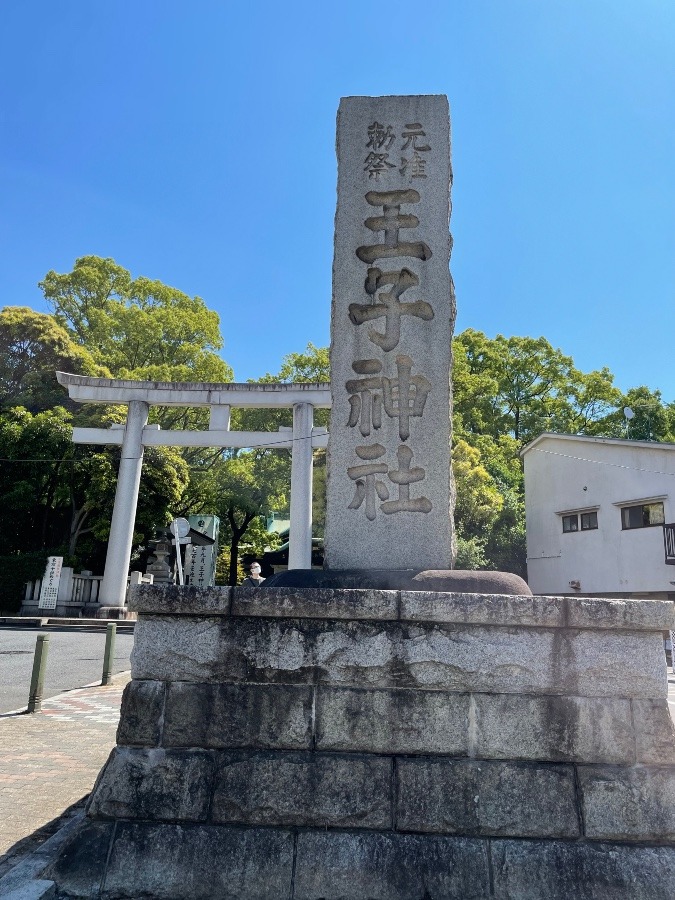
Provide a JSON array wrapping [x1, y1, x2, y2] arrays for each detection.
[[131, 616, 667, 698]]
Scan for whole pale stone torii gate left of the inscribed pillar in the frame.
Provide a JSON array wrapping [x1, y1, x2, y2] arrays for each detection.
[[56, 372, 331, 607]]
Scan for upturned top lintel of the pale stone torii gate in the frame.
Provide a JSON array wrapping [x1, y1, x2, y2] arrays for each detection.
[[56, 372, 331, 409]]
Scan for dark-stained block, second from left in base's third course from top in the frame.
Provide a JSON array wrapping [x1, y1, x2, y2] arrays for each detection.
[[164, 682, 313, 750]]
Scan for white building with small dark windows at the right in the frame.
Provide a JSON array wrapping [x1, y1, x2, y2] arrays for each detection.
[[521, 434, 675, 600]]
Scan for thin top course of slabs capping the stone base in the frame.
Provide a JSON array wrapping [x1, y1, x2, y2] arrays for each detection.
[[129, 584, 675, 631]]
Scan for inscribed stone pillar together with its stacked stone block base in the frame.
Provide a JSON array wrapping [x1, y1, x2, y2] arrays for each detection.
[[18, 97, 675, 900]]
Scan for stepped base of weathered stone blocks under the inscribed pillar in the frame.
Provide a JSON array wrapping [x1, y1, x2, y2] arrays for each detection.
[[44, 586, 675, 900]]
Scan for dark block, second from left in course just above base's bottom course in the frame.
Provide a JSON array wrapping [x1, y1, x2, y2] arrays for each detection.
[[211, 752, 392, 829]]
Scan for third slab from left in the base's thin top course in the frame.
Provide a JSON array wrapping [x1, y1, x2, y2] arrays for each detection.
[[401, 592, 565, 628]]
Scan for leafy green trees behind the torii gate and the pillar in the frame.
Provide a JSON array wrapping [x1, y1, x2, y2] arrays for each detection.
[[0, 256, 675, 604]]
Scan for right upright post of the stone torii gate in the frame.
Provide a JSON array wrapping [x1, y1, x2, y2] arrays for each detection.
[[288, 403, 314, 569]]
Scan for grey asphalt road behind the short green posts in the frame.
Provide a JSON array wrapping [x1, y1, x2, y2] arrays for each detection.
[[0, 626, 134, 714]]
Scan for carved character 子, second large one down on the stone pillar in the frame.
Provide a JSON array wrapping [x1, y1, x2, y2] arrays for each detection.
[[349, 268, 434, 352]]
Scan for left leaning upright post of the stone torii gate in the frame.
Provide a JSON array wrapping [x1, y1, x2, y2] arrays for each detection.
[[99, 400, 149, 607]]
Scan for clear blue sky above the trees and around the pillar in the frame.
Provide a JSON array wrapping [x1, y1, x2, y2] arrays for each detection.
[[0, 0, 675, 401]]
